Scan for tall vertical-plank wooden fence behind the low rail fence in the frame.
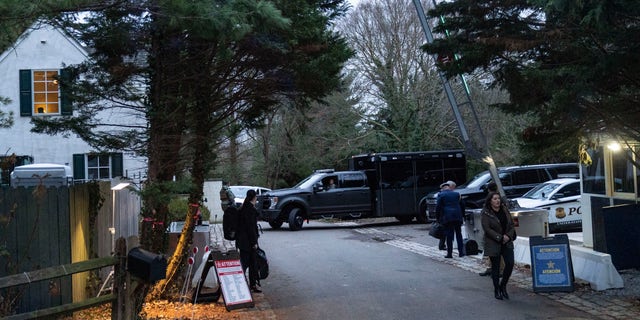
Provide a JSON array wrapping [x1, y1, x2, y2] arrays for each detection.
[[0, 181, 140, 314]]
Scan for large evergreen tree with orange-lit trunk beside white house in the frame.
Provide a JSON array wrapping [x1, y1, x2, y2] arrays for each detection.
[[21, 0, 351, 298]]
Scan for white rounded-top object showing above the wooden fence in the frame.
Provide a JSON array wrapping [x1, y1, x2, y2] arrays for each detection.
[[11, 163, 73, 188]]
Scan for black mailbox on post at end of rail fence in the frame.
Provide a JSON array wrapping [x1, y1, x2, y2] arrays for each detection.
[[127, 248, 167, 282]]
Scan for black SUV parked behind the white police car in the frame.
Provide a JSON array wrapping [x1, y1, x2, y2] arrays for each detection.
[[426, 163, 580, 221]]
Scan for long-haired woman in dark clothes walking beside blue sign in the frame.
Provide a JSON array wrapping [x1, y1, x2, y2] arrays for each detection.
[[482, 192, 516, 300]]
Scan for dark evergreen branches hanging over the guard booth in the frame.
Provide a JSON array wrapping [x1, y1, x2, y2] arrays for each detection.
[[425, 0, 640, 160]]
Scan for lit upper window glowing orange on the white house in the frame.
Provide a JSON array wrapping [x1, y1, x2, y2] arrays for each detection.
[[33, 70, 60, 115]]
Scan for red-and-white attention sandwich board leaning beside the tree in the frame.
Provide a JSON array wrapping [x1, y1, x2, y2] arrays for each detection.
[[211, 251, 255, 311]]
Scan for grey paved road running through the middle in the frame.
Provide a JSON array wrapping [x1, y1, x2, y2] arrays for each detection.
[[256, 222, 601, 320]]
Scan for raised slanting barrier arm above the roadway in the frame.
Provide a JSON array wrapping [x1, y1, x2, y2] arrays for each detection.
[[413, 0, 505, 198]]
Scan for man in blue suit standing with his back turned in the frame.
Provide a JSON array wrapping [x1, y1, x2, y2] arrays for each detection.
[[436, 181, 464, 258]]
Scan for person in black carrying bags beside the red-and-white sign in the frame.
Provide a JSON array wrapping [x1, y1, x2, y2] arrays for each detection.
[[236, 190, 262, 292]]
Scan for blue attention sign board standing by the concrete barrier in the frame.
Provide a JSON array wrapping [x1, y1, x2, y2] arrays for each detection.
[[529, 234, 574, 292]]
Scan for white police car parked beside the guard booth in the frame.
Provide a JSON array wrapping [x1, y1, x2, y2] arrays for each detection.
[[514, 178, 582, 233]]
